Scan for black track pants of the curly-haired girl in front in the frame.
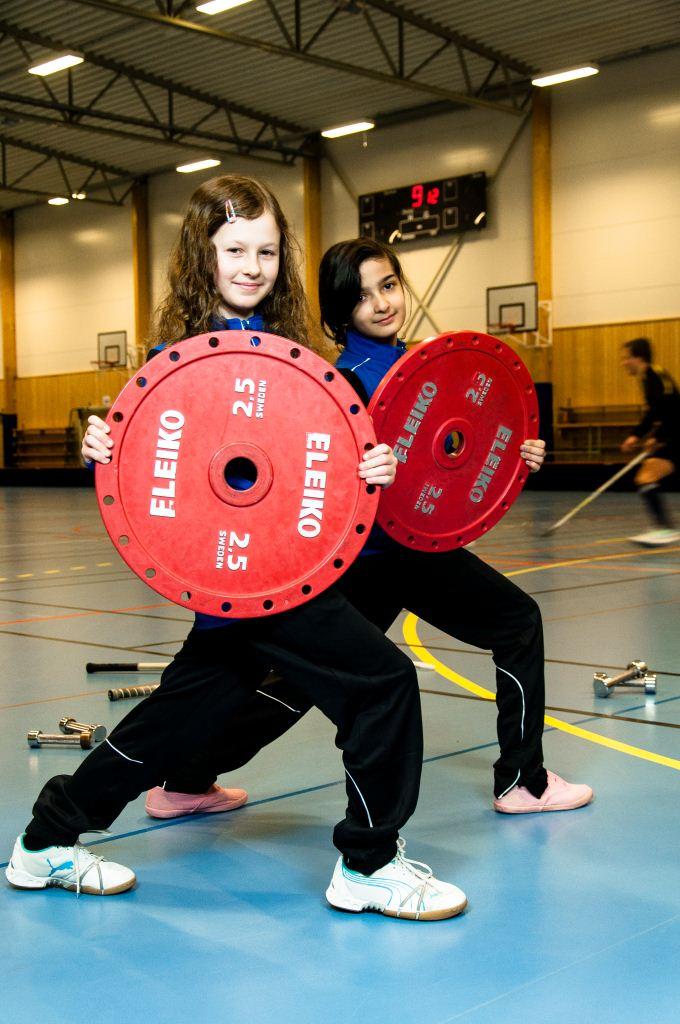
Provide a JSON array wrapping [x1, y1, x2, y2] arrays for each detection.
[[27, 588, 423, 873]]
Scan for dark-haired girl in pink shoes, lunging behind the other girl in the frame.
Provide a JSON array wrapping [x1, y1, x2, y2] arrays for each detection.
[[151, 239, 593, 814]]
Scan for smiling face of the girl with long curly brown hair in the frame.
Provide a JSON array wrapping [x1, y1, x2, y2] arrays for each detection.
[[212, 210, 281, 319]]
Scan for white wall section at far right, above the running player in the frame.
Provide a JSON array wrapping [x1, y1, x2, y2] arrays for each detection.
[[552, 50, 680, 327]]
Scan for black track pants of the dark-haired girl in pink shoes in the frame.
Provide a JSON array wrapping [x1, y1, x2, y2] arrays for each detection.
[[166, 545, 547, 797]]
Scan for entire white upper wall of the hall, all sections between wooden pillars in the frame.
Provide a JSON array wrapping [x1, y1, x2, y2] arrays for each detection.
[[6, 45, 680, 385]]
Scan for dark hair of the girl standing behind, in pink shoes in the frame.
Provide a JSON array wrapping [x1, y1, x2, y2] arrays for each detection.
[[318, 239, 409, 345]]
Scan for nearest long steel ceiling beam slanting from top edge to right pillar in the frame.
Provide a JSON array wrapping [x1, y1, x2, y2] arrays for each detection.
[[68, 0, 521, 116]]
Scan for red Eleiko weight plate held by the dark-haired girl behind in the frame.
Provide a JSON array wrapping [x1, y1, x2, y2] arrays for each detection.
[[369, 331, 539, 551]]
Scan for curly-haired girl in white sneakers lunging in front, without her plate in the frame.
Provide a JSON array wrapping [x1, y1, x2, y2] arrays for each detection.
[[6, 182, 466, 920]]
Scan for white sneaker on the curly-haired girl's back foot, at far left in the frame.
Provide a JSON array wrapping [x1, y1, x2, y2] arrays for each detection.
[[5, 836, 137, 896]]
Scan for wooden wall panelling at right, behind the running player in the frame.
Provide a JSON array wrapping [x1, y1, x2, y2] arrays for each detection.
[[553, 317, 680, 416]]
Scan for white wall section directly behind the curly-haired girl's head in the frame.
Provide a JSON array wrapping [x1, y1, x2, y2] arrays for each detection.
[[148, 157, 304, 306]]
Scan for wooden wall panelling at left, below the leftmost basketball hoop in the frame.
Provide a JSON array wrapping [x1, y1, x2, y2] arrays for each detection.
[[16, 370, 129, 429]]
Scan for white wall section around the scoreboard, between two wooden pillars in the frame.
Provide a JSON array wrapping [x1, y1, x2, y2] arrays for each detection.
[[324, 110, 533, 337]]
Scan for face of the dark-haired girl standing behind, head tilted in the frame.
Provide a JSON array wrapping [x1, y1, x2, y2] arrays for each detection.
[[351, 257, 407, 345]]
